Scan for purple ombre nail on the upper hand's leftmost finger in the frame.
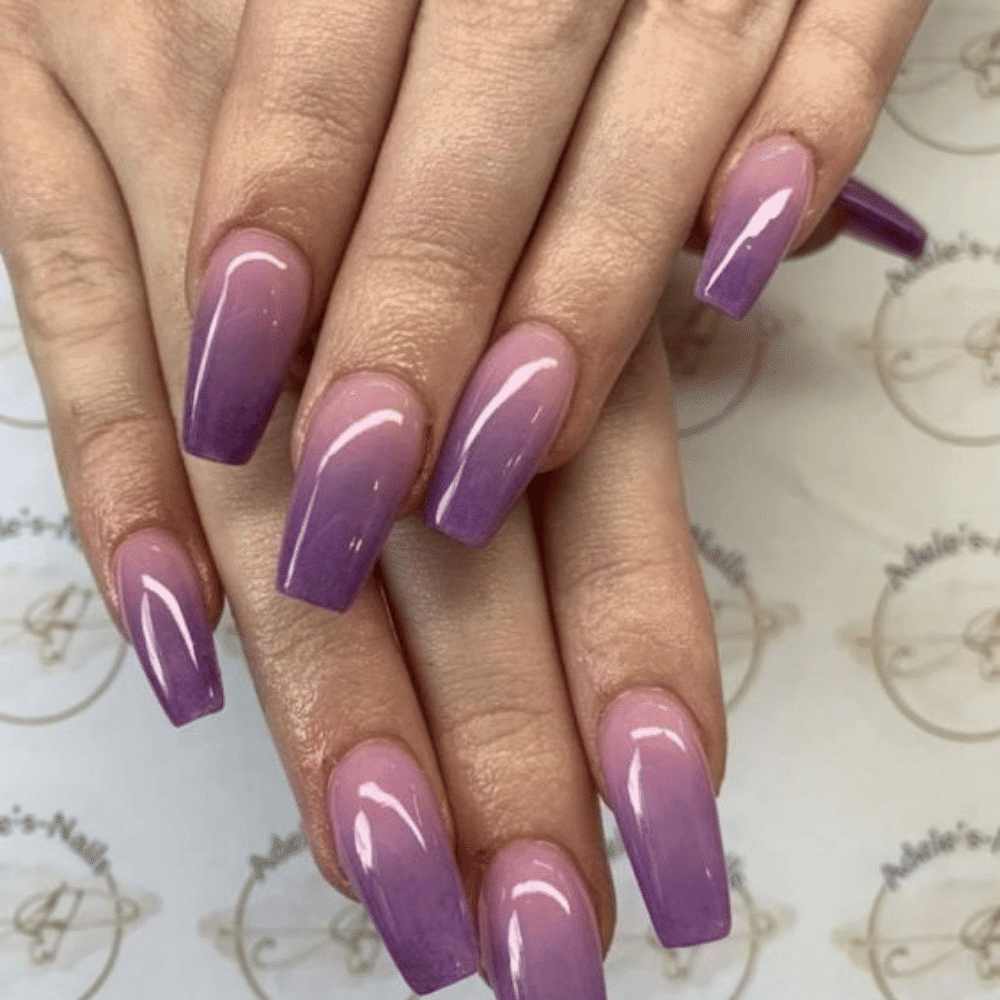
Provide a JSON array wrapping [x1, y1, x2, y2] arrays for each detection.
[[184, 229, 311, 465]]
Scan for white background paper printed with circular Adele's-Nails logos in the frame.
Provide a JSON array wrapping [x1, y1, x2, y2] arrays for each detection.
[[0, 0, 1000, 1000]]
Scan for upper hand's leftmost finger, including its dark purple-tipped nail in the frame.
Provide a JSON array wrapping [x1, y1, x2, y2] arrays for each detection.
[[184, 0, 417, 464]]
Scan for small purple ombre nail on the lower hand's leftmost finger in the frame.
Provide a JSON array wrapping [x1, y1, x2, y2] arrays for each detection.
[[114, 528, 223, 726]]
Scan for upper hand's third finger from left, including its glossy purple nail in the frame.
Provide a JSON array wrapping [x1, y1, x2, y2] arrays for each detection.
[[426, 0, 794, 556]]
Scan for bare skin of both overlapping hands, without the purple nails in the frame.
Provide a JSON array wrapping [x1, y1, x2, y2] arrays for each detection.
[[0, 0, 923, 984]]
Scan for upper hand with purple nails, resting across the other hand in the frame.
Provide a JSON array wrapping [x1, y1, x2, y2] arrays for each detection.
[[184, 0, 928, 610]]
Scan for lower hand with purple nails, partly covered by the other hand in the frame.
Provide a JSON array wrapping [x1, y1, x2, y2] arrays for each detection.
[[0, 0, 729, 998]]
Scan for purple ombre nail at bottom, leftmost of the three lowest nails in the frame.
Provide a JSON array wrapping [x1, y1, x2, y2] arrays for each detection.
[[328, 742, 479, 994]]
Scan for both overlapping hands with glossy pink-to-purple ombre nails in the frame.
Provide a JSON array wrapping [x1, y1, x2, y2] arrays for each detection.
[[0, 0, 926, 998]]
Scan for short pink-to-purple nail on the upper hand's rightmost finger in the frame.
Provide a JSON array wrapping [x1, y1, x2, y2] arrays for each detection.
[[695, 136, 813, 319]]
